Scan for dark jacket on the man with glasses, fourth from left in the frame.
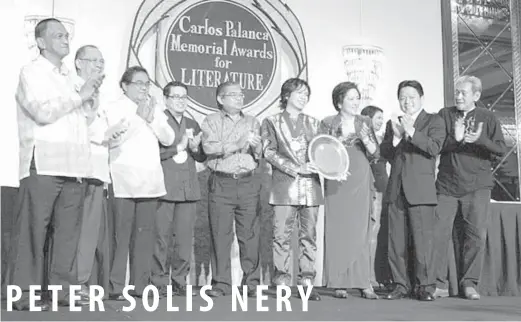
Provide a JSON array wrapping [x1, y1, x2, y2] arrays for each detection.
[[160, 110, 206, 201]]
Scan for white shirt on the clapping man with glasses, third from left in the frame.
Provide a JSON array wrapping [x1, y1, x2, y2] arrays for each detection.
[[104, 95, 175, 198]]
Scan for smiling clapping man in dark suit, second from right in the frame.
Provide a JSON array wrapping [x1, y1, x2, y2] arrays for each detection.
[[380, 80, 445, 301]]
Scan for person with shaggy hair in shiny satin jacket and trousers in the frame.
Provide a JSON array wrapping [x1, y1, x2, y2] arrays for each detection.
[[261, 78, 323, 301]]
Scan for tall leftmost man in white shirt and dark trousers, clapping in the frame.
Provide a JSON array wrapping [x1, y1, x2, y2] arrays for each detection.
[[9, 18, 101, 311]]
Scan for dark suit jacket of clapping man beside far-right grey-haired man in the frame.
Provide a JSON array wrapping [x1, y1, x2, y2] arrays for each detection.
[[380, 110, 446, 206]]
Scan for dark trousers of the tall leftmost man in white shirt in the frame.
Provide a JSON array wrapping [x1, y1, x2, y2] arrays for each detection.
[[9, 166, 86, 300]]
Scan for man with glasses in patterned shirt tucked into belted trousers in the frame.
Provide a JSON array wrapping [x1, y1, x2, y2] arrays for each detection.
[[201, 82, 262, 297]]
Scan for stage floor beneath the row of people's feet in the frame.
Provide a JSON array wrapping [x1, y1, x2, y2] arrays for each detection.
[[1, 289, 521, 321]]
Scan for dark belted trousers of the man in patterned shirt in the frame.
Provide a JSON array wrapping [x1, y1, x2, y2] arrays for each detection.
[[208, 174, 261, 294]]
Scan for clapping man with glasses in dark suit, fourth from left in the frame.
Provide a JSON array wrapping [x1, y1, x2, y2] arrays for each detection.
[[151, 81, 206, 295]]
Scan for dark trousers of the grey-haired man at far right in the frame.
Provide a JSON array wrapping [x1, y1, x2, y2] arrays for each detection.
[[435, 189, 490, 288]]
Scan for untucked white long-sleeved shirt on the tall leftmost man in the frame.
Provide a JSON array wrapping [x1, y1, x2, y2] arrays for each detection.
[[16, 56, 90, 180]]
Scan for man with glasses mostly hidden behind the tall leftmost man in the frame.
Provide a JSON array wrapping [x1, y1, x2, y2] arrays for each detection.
[[74, 45, 114, 297]]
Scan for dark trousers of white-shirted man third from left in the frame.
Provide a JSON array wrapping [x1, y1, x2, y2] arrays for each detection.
[[109, 198, 157, 295]]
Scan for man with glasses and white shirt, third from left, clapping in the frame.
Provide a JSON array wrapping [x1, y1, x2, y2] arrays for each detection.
[[105, 66, 175, 300]]
